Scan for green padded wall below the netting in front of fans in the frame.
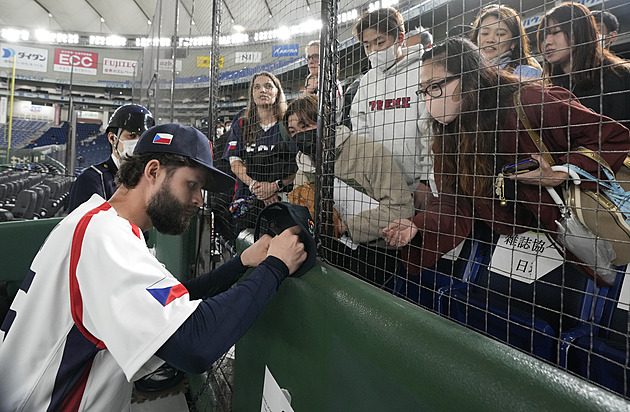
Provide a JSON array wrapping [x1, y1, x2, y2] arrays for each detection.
[[233, 232, 630, 412]]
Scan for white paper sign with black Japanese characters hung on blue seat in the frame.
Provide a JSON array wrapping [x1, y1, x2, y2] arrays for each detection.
[[490, 232, 563, 283]]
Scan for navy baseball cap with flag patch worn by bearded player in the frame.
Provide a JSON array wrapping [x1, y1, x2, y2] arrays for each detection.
[[133, 123, 234, 192]]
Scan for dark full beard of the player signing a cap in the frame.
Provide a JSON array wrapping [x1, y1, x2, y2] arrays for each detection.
[[147, 181, 197, 235]]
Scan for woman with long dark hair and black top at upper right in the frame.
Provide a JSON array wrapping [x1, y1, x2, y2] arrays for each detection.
[[537, 3, 630, 127]]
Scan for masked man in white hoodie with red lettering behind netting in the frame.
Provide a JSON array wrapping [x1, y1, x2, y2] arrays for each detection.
[[350, 8, 432, 209]]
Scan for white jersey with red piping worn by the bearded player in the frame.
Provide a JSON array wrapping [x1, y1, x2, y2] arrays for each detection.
[[0, 195, 200, 412]]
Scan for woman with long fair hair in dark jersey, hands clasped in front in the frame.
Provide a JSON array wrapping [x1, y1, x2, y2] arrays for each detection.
[[223, 72, 297, 226]]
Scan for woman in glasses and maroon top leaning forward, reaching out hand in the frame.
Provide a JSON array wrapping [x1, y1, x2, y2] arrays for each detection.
[[383, 38, 630, 284]]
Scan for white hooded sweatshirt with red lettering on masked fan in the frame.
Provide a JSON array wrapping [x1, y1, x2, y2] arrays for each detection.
[[350, 49, 433, 192]]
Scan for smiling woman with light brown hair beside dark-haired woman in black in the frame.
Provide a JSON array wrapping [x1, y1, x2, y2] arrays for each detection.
[[470, 4, 542, 78]]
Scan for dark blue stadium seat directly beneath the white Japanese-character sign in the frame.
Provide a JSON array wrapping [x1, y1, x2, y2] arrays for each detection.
[[438, 230, 595, 363]]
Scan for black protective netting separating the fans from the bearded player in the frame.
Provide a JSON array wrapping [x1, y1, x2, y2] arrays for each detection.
[[0, 0, 630, 410]]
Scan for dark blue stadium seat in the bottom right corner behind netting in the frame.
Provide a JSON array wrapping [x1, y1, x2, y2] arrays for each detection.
[[559, 271, 630, 397]]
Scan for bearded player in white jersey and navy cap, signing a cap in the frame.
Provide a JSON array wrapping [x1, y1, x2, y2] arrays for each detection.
[[0, 124, 307, 411]]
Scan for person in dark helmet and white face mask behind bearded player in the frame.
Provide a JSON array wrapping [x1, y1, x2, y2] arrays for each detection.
[[68, 104, 155, 212]]
